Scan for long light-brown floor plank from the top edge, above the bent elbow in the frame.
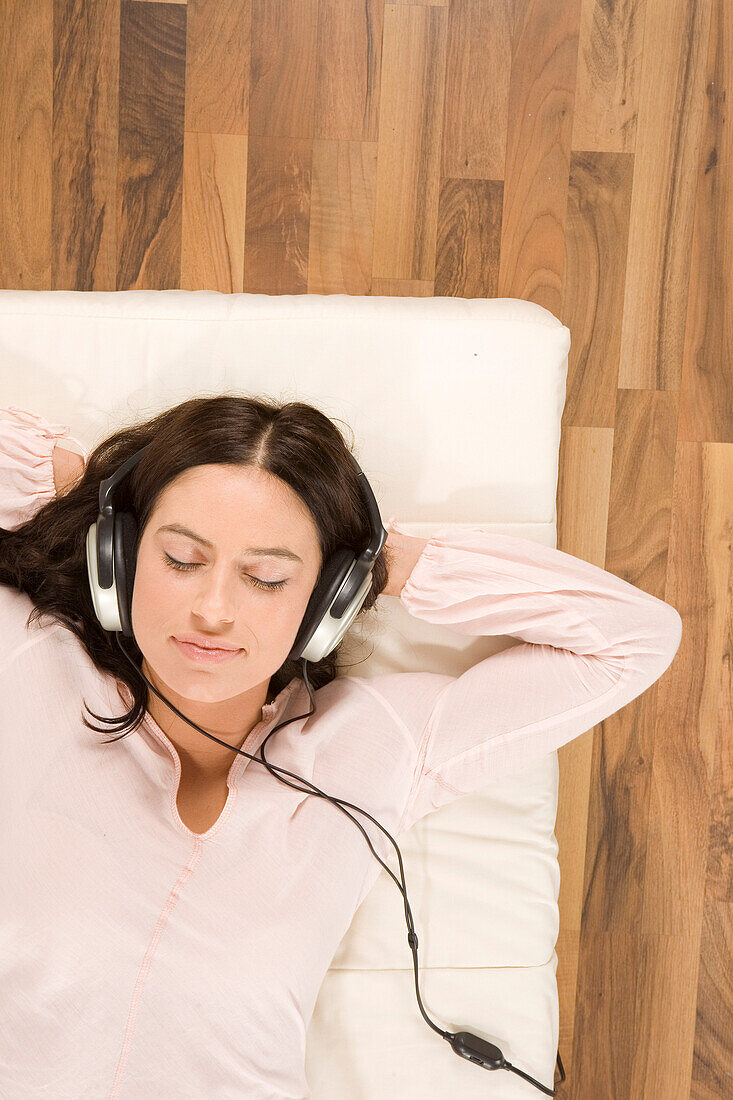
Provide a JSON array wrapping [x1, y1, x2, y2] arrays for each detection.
[[619, 0, 712, 389]]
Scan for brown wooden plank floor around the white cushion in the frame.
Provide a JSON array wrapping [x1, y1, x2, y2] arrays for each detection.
[[0, 0, 733, 1100]]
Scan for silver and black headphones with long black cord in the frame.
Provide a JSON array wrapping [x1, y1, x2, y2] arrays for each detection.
[[86, 443, 566, 1097]]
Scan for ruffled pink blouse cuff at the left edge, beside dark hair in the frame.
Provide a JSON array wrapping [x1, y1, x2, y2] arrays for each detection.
[[0, 405, 89, 531]]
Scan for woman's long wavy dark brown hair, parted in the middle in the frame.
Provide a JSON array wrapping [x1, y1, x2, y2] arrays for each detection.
[[0, 394, 391, 740]]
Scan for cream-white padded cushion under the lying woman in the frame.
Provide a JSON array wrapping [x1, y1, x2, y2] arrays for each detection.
[[0, 290, 570, 1100]]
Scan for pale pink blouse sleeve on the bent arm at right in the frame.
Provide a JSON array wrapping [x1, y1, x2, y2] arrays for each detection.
[[369, 525, 682, 831]]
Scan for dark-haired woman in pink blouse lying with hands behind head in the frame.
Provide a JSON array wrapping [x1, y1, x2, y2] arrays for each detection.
[[0, 395, 681, 1100]]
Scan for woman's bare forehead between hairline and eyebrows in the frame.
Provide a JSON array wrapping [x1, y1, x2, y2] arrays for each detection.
[[151, 465, 320, 558]]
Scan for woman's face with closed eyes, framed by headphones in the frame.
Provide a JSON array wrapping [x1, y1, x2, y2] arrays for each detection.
[[132, 465, 321, 721]]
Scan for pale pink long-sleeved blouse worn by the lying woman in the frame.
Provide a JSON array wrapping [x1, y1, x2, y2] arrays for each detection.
[[0, 406, 681, 1100]]
